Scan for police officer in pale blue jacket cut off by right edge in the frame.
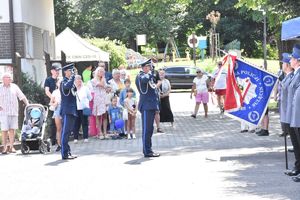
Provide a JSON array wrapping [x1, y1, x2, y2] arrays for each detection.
[[290, 45, 300, 182]]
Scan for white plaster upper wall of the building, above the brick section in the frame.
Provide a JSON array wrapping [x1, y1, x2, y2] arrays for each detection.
[[0, 0, 55, 33]]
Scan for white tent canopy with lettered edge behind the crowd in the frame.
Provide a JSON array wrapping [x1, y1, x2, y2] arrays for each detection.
[[55, 27, 109, 62]]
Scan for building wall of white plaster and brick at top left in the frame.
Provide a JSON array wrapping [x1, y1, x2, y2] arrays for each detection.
[[0, 0, 55, 83]]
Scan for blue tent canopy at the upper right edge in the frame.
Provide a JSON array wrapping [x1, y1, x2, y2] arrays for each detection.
[[281, 17, 300, 40]]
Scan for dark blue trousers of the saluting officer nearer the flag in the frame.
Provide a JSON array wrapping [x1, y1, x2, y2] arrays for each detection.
[[141, 110, 156, 155]]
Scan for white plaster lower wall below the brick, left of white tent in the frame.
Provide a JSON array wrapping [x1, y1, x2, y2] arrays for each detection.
[[21, 58, 47, 87]]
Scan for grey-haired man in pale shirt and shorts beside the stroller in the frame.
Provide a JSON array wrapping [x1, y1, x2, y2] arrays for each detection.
[[0, 73, 28, 154]]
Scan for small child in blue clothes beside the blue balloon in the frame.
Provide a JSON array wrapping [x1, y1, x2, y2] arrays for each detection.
[[108, 96, 122, 138]]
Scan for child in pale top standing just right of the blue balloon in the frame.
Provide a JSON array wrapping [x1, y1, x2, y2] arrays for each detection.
[[124, 88, 137, 139]]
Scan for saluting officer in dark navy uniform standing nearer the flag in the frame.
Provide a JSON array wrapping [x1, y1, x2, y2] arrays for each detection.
[[135, 59, 160, 157]]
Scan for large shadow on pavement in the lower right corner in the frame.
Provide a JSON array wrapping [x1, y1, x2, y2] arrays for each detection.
[[220, 152, 300, 200]]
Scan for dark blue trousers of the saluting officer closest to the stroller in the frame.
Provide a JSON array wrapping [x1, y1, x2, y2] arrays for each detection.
[[61, 114, 76, 158]]
